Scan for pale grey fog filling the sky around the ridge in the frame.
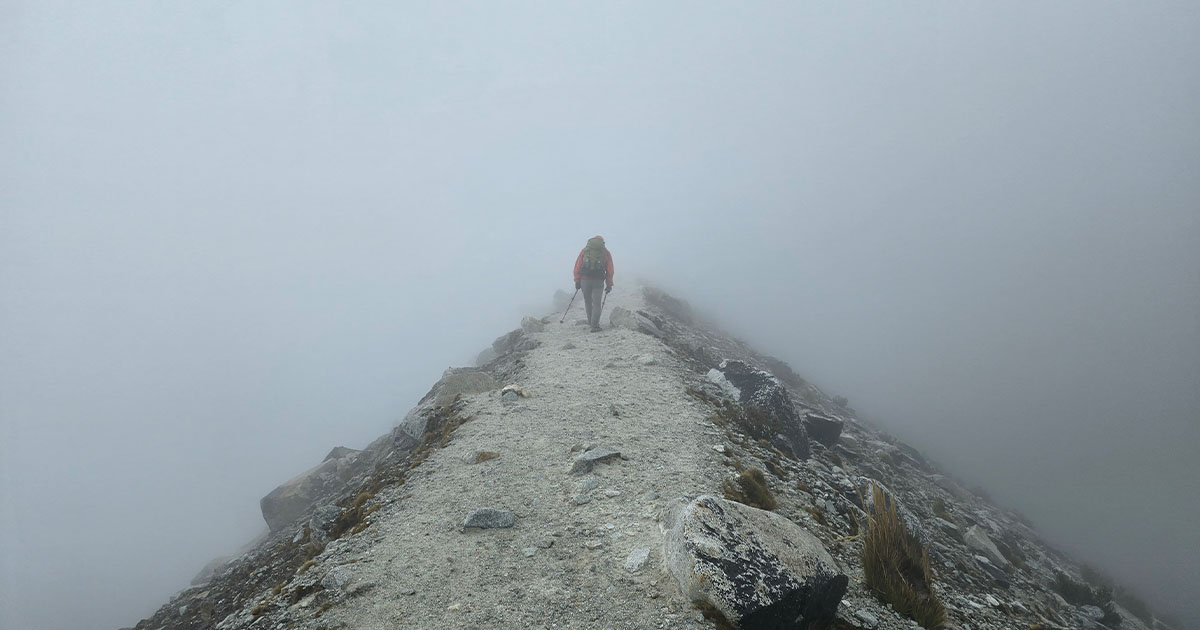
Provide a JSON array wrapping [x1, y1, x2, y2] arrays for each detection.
[[0, 0, 1200, 630]]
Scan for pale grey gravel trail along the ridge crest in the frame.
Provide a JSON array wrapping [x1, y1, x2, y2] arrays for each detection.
[[308, 288, 724, 629]]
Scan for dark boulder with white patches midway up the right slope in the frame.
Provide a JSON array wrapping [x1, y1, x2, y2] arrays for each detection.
[[708, 360, 811, 460]]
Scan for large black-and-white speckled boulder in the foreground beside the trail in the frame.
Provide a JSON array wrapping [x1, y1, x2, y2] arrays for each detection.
[[661, 496, 848, 630]]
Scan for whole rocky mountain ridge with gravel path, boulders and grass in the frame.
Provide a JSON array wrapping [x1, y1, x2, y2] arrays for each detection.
[[126, 280, 1164, 630]]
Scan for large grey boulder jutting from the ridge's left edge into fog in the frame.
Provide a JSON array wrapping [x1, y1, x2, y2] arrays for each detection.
[[258, 446, 365, 532]]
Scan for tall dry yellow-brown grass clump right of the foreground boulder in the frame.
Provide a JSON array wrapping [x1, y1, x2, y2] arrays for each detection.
[[863, 484, 946, 628]]
